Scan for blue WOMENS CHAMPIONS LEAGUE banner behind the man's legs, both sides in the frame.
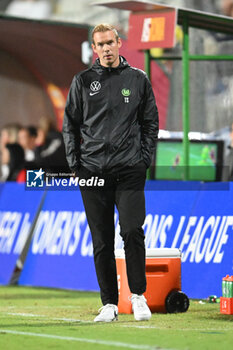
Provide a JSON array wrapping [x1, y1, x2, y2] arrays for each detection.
[[19, 181, 233, 298]]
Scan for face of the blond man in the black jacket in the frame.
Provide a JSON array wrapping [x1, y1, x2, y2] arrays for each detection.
[[92, 30, 122, 67]]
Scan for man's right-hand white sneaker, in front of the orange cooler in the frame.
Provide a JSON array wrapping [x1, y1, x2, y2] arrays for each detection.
[[131, 294, 151, 321]]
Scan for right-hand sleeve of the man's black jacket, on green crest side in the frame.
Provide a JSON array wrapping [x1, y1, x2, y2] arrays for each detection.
[[140, 75, 159, 167]]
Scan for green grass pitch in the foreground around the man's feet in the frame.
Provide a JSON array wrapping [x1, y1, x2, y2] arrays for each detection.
[[0, 287, 233, 350]]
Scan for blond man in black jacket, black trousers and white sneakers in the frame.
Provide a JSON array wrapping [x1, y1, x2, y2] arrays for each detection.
[[63, 24, 158, 322]]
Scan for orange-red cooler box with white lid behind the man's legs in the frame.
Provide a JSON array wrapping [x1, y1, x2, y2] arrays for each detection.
[[115, 248, 181, 314]]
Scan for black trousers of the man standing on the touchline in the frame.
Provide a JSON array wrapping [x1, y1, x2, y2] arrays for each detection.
[[79, 162, 146, 305]]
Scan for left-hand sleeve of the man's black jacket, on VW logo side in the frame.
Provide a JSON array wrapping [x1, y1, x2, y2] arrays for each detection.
[[62, 76, 82, 172]]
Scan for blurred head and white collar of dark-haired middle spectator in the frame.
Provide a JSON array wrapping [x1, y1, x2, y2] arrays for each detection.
[[18, 126, 37, 162]]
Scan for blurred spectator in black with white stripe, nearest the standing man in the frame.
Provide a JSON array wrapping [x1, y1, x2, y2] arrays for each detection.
[[35, 117, 70, 173]]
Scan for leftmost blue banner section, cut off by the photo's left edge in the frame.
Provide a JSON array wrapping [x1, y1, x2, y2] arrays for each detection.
[[0, 182, 43, 284]]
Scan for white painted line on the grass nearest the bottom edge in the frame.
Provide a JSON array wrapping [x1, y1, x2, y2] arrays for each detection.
[[0, 329, 172, 350]]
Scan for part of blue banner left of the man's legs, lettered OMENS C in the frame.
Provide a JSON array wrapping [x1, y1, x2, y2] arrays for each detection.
[[19, 190, 99, 291]]
